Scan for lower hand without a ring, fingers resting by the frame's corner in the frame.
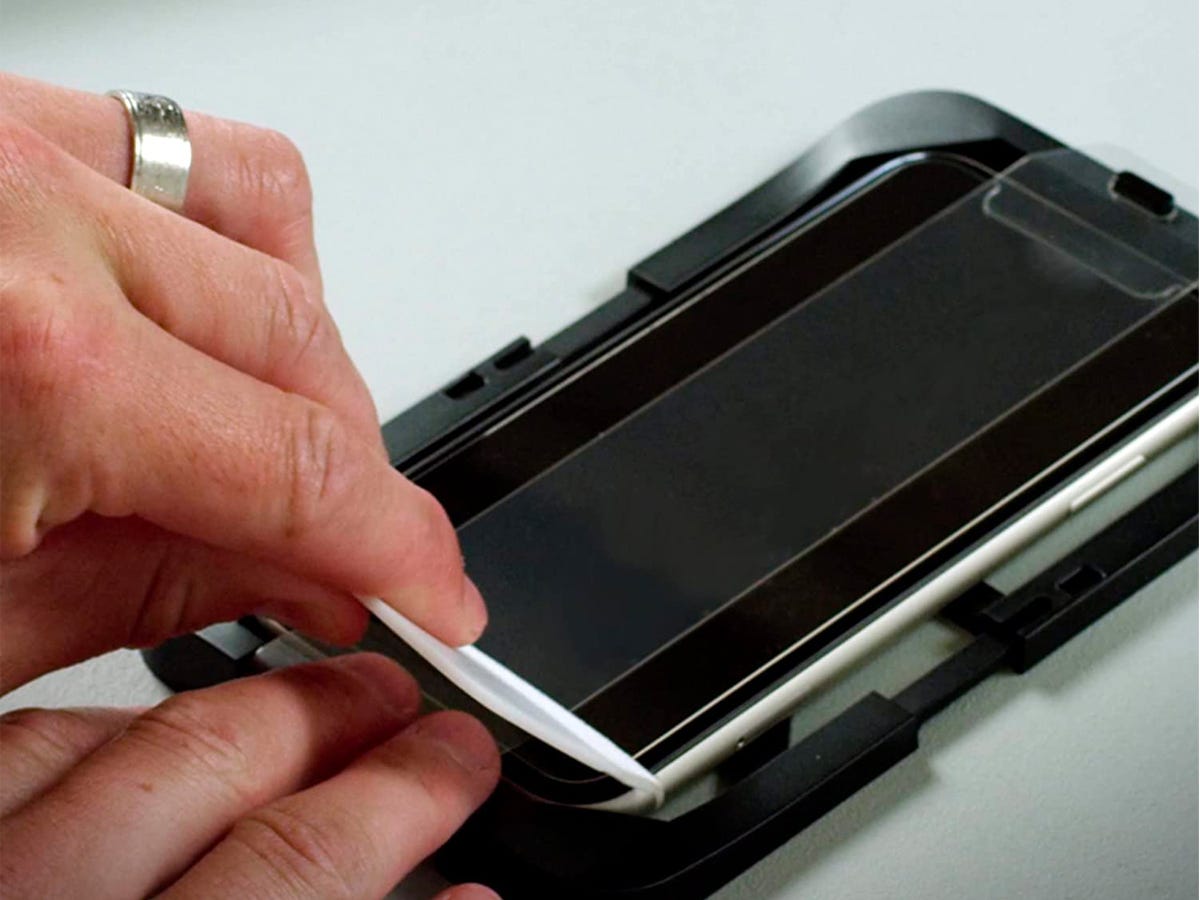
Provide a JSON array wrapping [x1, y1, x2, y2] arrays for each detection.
[[0, 654, 499, 900]]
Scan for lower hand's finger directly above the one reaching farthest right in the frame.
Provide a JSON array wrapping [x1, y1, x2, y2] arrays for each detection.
[[0, 654, 420, 898]]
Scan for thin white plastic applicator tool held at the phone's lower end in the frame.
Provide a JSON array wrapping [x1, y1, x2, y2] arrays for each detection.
[[360, 598, 664, 806]]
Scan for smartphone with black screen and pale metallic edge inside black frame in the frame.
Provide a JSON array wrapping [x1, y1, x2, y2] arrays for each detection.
[[365, 152, 1196, 811]]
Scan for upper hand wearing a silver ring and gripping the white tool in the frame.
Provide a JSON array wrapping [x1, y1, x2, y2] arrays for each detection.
[[0, 74, 486, 690]]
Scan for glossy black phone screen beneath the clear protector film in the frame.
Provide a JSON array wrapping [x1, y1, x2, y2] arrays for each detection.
[[360, 161, 1194, 796]]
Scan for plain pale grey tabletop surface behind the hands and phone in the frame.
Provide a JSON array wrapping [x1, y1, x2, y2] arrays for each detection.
[[0, 0, 1198, 900]]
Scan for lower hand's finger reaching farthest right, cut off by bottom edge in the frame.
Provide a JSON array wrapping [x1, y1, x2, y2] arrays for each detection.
[[162, 713, 499, 900]]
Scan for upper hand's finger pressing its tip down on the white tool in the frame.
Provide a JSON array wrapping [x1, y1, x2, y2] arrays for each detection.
[[59, 300, 487, 644]]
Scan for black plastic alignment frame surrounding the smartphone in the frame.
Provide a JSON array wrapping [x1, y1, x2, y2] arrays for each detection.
[[144, 91, 1196, 900]]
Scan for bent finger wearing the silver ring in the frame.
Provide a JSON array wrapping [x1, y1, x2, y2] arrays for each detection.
[[0, 72, 320, 284]]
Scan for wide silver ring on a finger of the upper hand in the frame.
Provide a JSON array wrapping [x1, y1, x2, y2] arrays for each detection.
[[108, 91, 192, 212]]
